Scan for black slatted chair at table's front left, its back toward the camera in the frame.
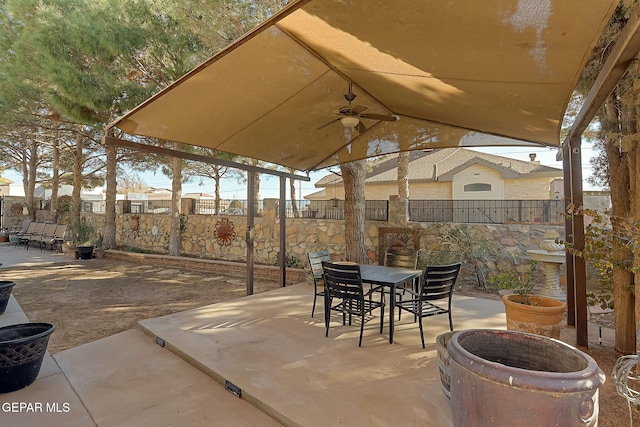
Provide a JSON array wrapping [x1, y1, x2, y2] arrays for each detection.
[[322, 261, 384, 347]]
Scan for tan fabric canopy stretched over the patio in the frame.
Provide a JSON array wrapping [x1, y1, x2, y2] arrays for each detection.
[[107, 0, 618, 171]]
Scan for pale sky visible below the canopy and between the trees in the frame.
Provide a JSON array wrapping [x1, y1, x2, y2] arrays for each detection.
[[2, 143, 597, 200]]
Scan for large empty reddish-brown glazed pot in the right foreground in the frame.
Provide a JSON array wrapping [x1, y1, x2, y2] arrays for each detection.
[[447, 329, 605, 427]]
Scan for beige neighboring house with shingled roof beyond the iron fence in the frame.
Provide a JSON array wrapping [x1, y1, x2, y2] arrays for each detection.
[[305, 148, 563, 200]]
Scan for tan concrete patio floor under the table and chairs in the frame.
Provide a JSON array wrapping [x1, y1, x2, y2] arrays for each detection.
[[0, 248, 608, 426]]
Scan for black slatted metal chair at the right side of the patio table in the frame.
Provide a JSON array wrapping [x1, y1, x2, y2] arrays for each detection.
[[396, 263, 461, 348]]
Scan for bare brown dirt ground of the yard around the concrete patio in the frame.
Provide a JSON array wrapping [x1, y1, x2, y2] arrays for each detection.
[[1, 259, 640, 427]]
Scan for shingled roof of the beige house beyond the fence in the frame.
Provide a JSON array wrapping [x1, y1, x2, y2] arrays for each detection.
[[315, 148, 563, 187]]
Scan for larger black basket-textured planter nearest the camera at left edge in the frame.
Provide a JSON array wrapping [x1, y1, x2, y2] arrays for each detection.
[[0, 323, 55, 393]]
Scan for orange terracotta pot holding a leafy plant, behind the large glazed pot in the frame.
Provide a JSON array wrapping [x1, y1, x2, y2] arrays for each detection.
[[502, 295, 567, 339]]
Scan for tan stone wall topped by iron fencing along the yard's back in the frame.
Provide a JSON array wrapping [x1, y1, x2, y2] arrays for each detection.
[[79, 199, 564, 277]]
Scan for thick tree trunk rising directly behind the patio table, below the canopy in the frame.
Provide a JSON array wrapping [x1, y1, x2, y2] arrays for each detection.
[[340, 160, 369, 264]]
